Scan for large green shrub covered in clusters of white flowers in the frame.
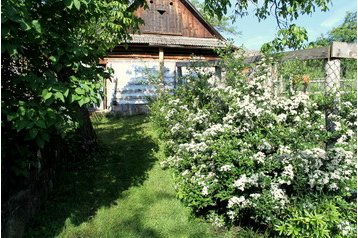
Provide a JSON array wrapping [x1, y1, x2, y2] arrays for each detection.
[[151, 52, 356, 237]]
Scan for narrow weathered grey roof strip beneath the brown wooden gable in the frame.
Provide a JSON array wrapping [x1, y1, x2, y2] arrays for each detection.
[[128, 34, 226, 49]]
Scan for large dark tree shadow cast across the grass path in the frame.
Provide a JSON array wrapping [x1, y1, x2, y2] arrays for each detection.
[[25, 117, 157, 237]]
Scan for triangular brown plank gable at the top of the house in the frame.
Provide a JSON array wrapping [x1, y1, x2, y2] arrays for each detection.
[[137, 0, 223, 39]]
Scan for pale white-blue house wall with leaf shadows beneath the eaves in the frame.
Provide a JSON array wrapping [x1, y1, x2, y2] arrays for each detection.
[[106, 59, 176, 114]]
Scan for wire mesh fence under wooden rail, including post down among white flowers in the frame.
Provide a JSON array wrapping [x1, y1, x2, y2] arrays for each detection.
[[262, 54, 357, 144]]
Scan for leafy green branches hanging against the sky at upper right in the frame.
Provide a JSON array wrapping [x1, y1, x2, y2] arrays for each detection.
[[204, 0, 331, 51]]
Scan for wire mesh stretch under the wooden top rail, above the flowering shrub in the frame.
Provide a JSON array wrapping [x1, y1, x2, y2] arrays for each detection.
[[276, 59, 357, 94]]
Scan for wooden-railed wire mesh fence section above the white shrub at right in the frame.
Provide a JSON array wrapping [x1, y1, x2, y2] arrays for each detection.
[[245, 42, 357, 96]]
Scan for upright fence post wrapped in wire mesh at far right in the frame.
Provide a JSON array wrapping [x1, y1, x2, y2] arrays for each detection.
[[325, 59, 341, 148]]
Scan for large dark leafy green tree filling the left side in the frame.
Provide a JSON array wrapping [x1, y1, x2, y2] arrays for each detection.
[[1, 0, 143, 188]]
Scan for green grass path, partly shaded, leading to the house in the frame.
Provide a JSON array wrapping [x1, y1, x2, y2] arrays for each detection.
[[25, 117, 258, 238]]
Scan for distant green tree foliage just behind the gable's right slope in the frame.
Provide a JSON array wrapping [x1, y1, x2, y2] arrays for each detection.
[[191, 0, 239, 34]]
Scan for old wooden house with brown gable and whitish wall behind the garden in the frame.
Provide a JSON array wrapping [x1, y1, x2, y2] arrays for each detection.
[[101, 0, 225, 115]]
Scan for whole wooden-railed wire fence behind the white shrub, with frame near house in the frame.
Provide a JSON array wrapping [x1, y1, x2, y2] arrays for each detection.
[[176, 42, 357, 147]]
